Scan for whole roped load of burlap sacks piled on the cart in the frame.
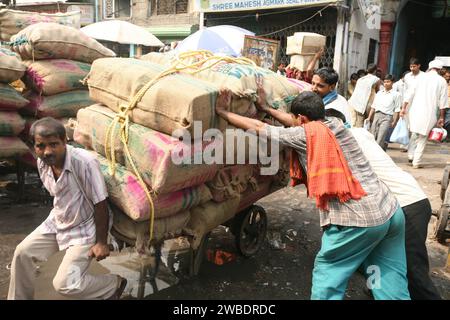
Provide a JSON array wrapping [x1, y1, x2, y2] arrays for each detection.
[[74, 53, 298, 250]]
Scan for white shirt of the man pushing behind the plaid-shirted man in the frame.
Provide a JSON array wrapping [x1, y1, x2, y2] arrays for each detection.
[[350, 128, 427, 208]]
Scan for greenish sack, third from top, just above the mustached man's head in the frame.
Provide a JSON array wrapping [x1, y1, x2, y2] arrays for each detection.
[[20, 90, 93, 118]]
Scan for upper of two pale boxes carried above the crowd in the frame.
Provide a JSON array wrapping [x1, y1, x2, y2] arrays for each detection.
[[286, 32, 327, 55]]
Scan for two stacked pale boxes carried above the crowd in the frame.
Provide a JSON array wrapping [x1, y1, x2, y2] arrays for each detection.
[[286, 32, 327, 71]]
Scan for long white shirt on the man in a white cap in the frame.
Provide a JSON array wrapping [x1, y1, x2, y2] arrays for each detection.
[[408, 70, 448, 136]]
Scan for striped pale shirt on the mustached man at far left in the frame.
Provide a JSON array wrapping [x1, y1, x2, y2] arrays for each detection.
[[38, 145, 108, 250]]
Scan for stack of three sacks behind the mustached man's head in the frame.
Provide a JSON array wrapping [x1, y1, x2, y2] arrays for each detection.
[[6, 22, 114, 147]]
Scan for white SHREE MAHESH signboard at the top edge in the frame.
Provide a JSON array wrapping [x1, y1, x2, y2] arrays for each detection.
[[194, 0, 338, 12]]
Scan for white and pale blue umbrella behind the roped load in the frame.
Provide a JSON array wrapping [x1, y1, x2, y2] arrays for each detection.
[[175, 25, 255, 57]]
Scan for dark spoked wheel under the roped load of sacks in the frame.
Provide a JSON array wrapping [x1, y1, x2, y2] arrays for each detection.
[[233, 205, 267, 257]]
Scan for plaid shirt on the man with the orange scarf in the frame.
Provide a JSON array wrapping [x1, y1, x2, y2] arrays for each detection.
[[266, 118, 399, 227]]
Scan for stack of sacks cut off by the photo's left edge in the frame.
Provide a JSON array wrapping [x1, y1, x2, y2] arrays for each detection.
[[0, 48, 28, 160]]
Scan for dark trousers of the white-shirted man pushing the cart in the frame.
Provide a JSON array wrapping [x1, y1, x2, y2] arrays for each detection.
[[403, 199, 442, 300]]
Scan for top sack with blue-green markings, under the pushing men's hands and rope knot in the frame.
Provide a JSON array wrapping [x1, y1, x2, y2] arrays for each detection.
[[141, 52, 298, 111]]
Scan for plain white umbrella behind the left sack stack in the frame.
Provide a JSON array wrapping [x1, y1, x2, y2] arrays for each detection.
[[80, 20, 164, 47]]
